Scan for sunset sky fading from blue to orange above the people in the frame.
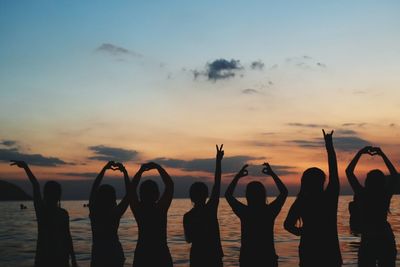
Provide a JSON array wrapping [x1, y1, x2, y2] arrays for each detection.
[[0, 0, 400, 197]]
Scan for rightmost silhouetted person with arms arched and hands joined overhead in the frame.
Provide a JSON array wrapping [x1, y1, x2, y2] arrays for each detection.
[[346, 146, 398, 267]]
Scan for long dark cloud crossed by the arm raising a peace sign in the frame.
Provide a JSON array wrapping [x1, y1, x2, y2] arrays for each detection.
[[152, 156, 264, 173]]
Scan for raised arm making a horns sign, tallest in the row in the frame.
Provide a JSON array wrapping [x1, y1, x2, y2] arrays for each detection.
[[322, 130, 340, 196]]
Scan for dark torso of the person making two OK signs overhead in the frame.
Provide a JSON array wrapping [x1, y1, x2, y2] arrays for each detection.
[[233, 201, 282, 266]]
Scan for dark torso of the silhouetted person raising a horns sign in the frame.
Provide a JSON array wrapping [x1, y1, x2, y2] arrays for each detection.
[[293, 189, 342, 267]]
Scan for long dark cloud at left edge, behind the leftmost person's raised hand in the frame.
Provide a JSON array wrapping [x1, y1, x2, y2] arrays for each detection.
[[0, 148, 68, 167]]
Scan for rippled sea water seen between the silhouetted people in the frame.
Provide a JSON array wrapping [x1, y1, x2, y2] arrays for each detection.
[[0, 196, 400, 267]]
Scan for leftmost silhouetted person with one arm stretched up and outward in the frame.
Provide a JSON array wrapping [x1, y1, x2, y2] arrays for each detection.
[[11, 160, 77, 267]]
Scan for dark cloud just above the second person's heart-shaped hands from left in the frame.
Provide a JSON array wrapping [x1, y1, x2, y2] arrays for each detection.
[[89, 145, 139, 162]]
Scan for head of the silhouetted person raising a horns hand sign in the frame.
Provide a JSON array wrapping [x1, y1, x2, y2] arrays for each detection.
[[300, 167, 325, 196]]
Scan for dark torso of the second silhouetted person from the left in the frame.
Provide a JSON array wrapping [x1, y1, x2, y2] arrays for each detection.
[[89, 209, 125, 267]]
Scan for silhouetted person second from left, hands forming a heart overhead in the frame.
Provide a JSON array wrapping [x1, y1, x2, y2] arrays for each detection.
[[89, 161, 130, 267]]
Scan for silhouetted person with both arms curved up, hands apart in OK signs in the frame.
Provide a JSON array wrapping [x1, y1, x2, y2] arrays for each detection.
[[225, 163, 288, 267]]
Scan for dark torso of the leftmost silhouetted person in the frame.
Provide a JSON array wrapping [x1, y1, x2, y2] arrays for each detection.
[[35, 207, 70, 267]]
